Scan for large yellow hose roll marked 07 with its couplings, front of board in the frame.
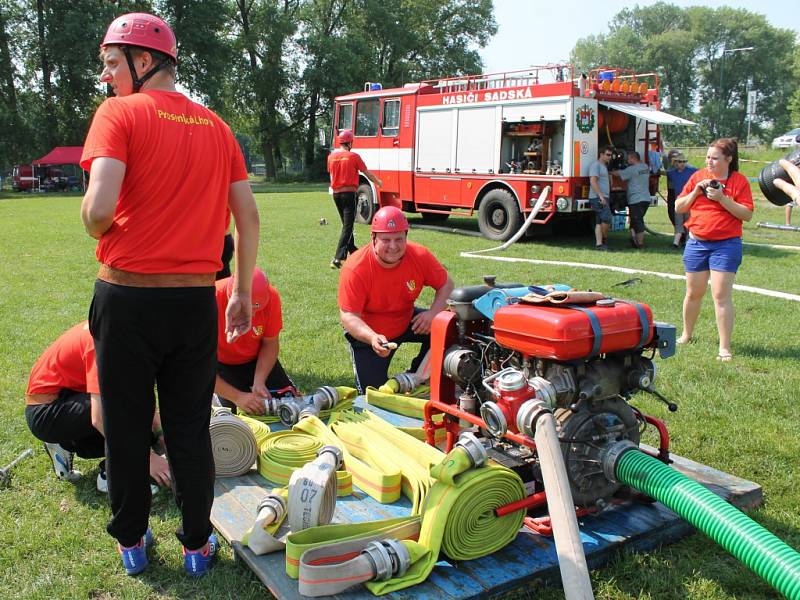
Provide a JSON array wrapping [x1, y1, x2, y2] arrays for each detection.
[[286, 434, 525, 596]]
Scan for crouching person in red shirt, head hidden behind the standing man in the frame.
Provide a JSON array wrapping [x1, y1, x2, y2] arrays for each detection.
[[25, 321, 170, 492]]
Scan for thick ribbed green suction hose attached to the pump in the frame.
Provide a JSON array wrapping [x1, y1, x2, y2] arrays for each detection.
[[603, 443, 800, 600]]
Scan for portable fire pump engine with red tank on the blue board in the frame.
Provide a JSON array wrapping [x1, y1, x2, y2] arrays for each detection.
[[424, 277, 677, 512]]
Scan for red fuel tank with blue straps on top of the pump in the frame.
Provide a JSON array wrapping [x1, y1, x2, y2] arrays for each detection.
[[493, 300, 653, 361]]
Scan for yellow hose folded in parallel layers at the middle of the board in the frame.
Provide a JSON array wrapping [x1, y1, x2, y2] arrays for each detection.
[[331, 410, 443, 515]]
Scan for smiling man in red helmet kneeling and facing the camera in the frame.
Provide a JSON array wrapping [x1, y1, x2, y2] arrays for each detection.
[[339, 206, 453, 394]]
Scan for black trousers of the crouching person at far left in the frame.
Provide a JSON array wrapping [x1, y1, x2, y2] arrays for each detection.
[[25, 389, 106, 458]]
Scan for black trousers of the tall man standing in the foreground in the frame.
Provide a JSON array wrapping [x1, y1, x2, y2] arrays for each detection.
[[89, 281, 217, 550]]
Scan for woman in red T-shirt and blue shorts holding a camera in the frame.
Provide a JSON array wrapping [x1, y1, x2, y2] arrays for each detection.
[[675, 138, 753, 361]]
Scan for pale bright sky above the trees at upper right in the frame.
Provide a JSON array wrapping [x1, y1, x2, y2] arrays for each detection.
[[481, 0, 800, 73]]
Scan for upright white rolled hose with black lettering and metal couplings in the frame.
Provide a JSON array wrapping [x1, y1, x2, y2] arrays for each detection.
[[242, 446, 342, 554]]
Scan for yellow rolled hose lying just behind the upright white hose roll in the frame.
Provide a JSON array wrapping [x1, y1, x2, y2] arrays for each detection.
[[258, 430, 353, 496]]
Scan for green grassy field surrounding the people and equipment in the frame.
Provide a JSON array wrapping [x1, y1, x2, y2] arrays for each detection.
[[0, 184, 800, 600]]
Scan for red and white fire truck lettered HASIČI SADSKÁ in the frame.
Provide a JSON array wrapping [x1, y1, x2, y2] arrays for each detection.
[[334, 65, 693, 240]]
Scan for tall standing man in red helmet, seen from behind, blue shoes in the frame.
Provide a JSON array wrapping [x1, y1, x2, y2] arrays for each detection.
[[81, 13, 259, 575]]
